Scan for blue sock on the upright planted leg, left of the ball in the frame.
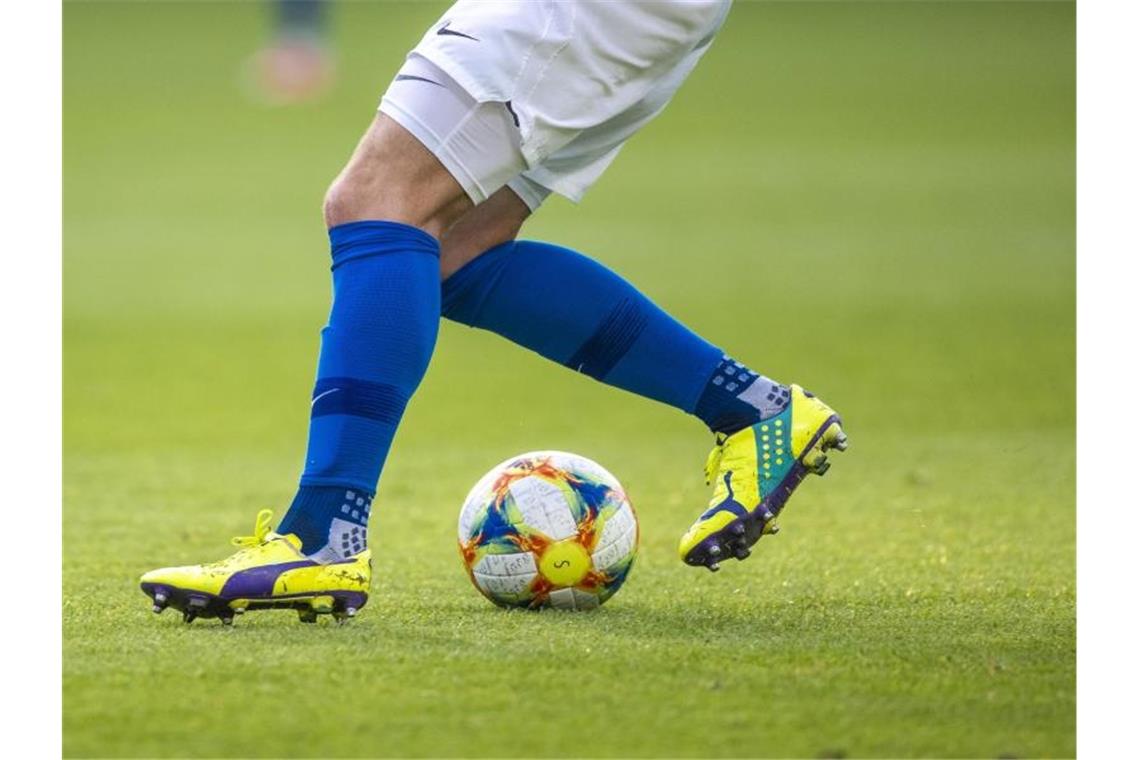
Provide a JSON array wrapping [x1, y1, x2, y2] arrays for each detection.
[[277, 221, 440, 561]]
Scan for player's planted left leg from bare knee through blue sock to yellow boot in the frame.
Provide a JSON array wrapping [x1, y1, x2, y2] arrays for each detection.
[[141, 114, 481, 622]]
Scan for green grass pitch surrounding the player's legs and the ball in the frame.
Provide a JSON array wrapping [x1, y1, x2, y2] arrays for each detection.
[[64, 2, 1075, 758]]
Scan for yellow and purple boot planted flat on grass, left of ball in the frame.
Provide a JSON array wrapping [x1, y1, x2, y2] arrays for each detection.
[[140, 509, 372, 626]]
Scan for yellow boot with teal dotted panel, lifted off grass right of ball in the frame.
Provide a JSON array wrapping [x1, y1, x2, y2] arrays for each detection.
[[679, 385, 847, 571]]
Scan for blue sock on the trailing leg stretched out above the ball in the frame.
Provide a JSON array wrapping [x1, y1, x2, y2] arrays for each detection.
[[442, 240, 788, 433]]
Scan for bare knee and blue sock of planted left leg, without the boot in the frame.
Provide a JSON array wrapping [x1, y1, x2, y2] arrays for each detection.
[[277, 114, 472, 562]]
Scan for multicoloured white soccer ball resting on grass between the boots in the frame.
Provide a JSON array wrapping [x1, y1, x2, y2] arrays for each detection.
[[459, 451, 637, 610]]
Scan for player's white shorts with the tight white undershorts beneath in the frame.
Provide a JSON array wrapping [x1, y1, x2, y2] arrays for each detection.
[[380, 0, 731, 210]]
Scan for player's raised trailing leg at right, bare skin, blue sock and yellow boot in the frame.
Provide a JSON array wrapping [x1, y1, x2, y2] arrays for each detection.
[[441, 184, 846, 570]]
